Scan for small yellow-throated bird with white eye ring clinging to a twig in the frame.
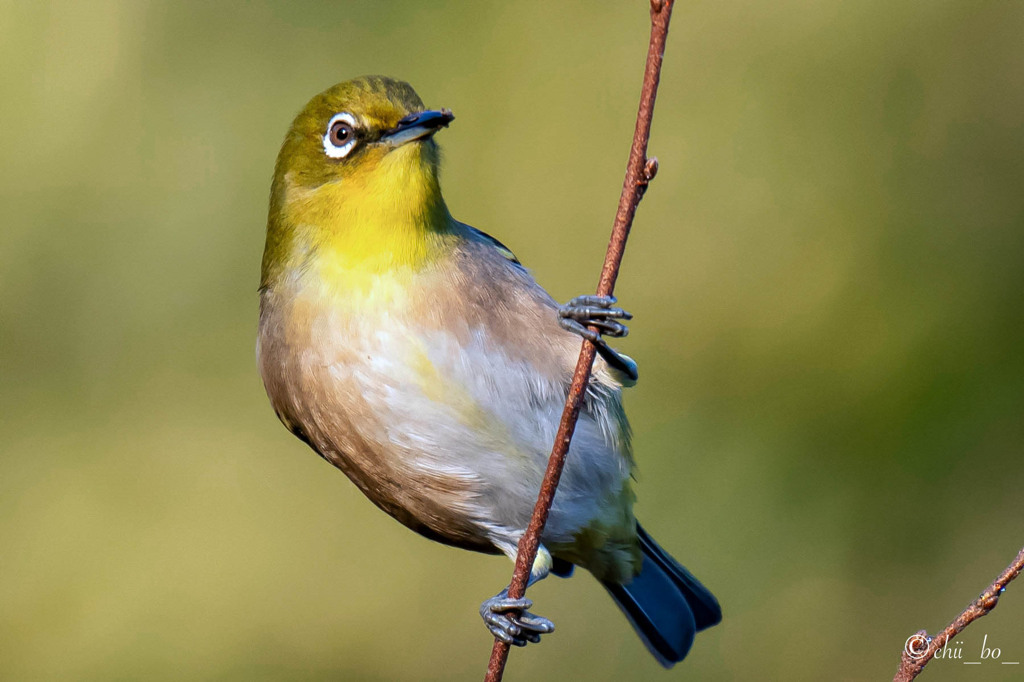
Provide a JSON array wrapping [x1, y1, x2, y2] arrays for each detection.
[[257, 76, 722, 667]]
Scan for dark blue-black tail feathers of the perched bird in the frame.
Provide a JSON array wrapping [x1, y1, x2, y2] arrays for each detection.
[[604, 523, 722, 668]]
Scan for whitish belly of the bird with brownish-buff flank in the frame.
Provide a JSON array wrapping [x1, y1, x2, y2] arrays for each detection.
[[260, 268, 630, 554]]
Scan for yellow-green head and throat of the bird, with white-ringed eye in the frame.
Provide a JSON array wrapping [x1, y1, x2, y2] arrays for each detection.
[[262, 76, 455, 287]]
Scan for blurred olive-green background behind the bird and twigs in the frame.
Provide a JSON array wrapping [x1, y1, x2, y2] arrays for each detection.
[[0, 0, 1024, 680]]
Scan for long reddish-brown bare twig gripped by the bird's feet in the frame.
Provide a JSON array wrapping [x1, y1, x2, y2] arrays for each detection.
[[484, 0, 674, 682]]
